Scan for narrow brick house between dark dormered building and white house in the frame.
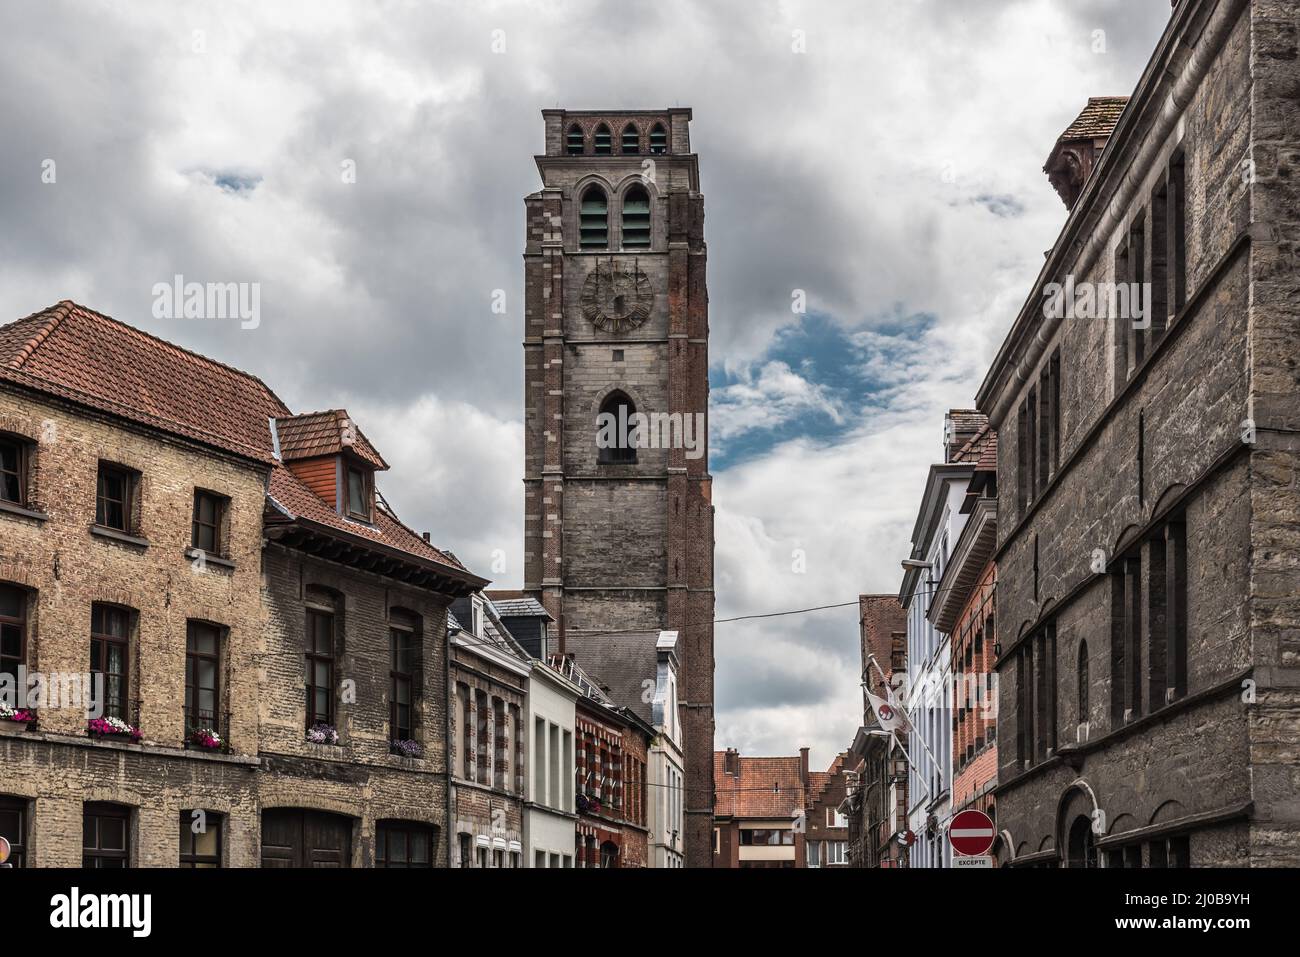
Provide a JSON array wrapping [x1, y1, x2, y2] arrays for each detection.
[[447, 594, 532, 867]]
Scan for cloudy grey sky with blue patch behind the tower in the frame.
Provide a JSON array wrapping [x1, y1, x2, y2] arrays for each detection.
[[0, 0, 1170, 766]]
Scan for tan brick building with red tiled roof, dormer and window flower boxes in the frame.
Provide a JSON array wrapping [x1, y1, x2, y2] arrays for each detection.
[[0, 302, 484, 867]]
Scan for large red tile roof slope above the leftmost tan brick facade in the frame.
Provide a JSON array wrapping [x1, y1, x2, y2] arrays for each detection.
[[0, 299, 289, 463]]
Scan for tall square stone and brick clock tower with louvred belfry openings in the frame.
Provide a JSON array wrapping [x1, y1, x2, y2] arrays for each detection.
[[524, 109, 714, 867]]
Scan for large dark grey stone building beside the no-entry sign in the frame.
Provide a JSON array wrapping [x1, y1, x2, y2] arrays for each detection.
[[978, 0, 1300, 867]]
